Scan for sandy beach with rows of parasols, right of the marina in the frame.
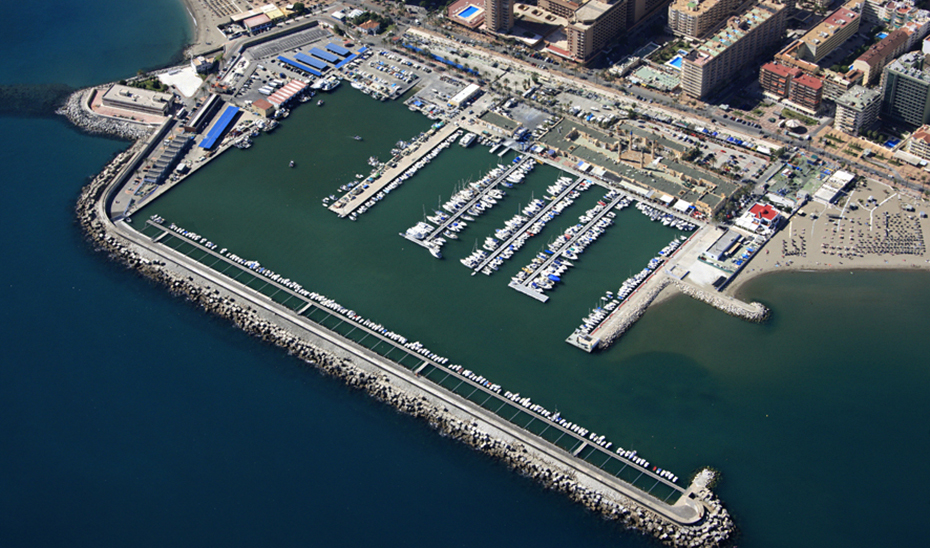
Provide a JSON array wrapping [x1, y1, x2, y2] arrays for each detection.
[[725, 176, 930, 295]]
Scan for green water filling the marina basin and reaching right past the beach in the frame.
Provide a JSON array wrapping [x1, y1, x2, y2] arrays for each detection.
[[135, 87, 930, 546]]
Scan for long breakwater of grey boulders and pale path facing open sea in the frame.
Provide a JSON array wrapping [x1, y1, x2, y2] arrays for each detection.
[[76, 151, 734, 547]]
